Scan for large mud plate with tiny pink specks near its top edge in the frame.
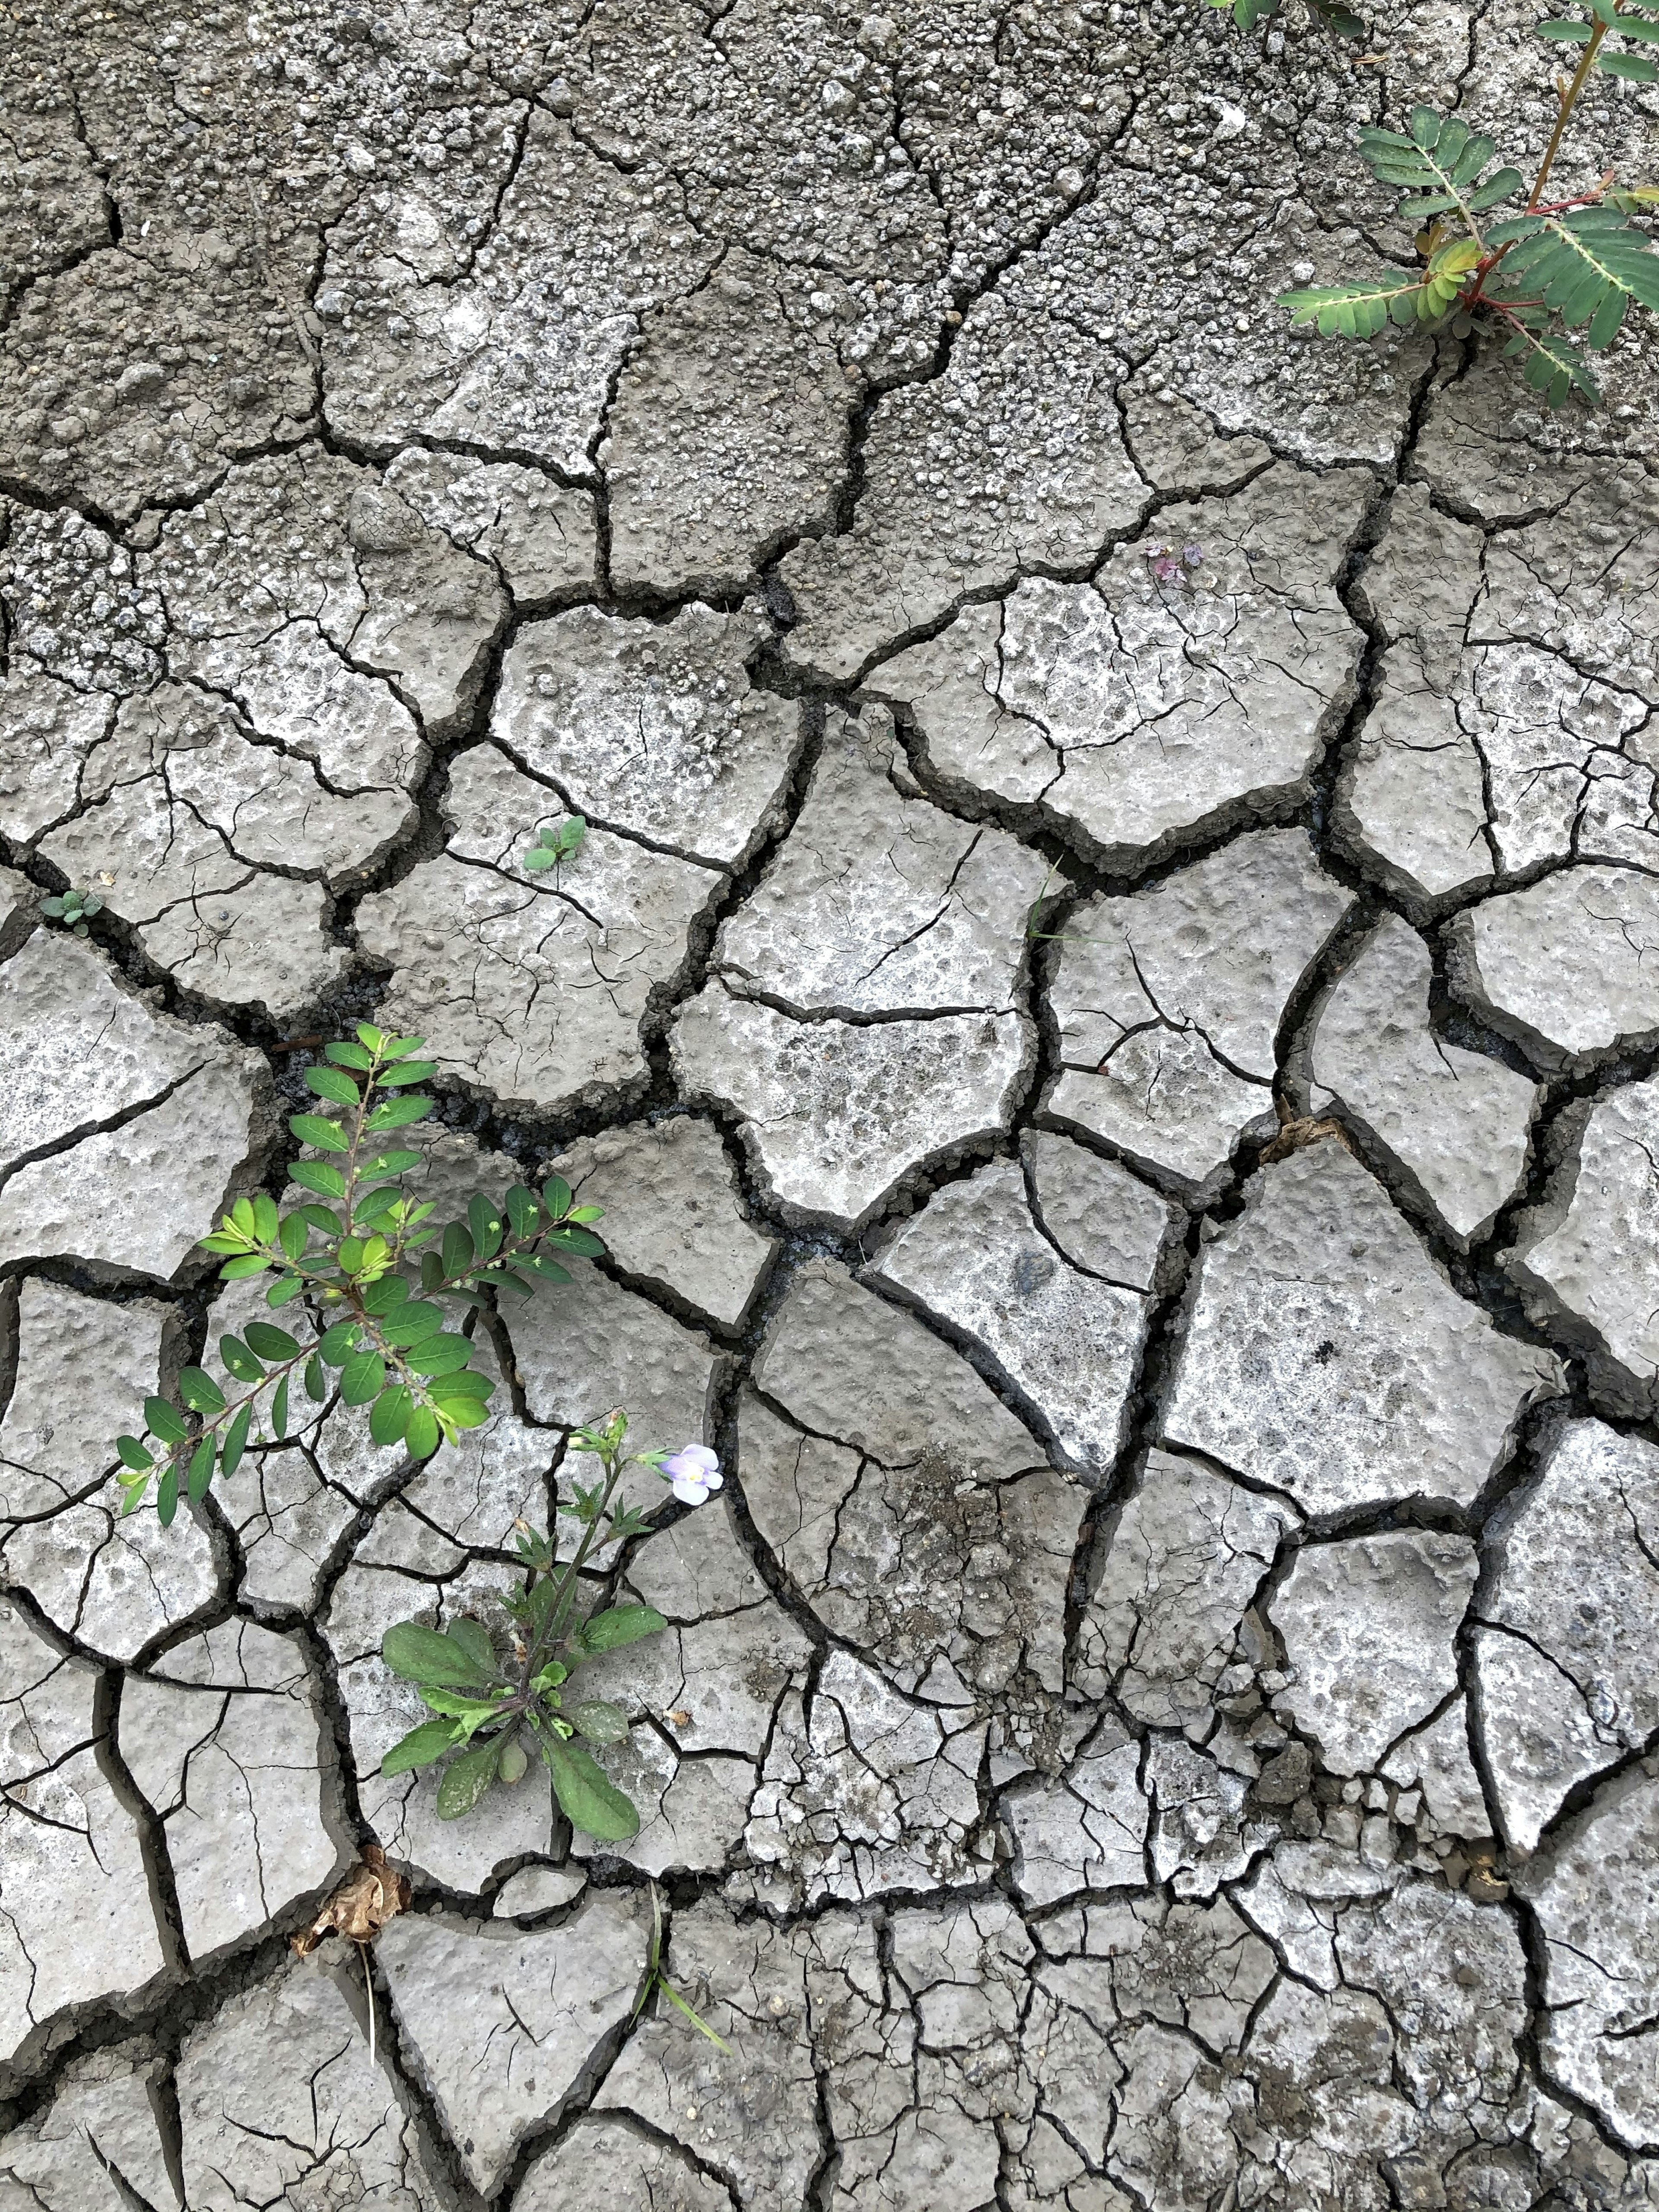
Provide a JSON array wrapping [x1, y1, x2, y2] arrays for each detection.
[[871, 467, 1365, 867]]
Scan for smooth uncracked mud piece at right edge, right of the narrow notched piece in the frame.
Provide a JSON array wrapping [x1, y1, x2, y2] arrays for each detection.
[[1451, 865, 1659, 1068]]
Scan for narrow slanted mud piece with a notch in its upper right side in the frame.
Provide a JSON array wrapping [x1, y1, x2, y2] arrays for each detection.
[[1309, 916, 1537, 1250]]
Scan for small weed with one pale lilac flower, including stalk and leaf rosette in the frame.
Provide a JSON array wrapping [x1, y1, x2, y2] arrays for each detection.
[[381, 1411, 721, 1843]]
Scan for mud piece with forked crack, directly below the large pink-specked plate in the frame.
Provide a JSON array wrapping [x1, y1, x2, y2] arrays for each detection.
[[1044, 830, 1349, 1195]]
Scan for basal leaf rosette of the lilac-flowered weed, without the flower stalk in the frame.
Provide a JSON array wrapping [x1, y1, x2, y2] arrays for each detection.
[[381, 1577, 668, 1843]]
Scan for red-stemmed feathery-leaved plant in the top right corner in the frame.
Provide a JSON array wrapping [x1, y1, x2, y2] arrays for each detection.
[[1278, 0, 1659, 407]]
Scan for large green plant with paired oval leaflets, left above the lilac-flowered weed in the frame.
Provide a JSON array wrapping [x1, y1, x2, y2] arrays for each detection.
[[115, 1022, 604, 1524]]
